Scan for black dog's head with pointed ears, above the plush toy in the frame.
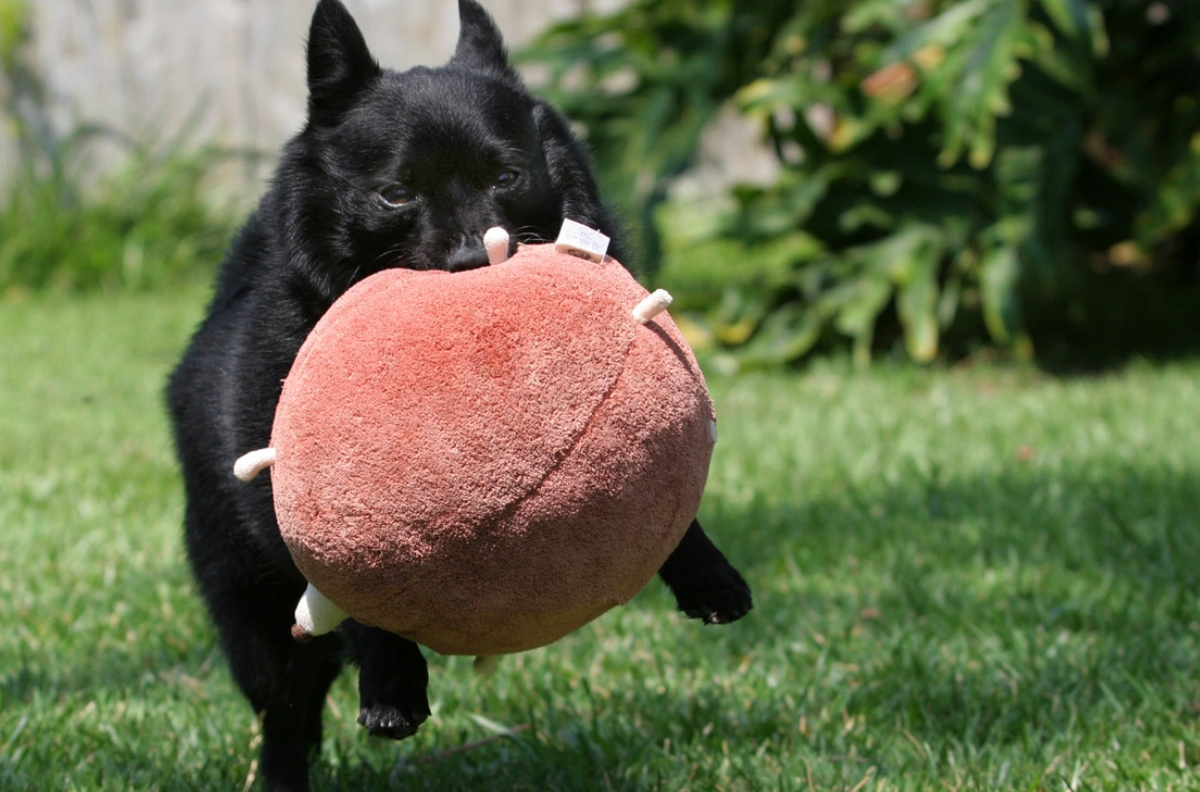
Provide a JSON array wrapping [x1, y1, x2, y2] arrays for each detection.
[[275, 0, 616, 296]]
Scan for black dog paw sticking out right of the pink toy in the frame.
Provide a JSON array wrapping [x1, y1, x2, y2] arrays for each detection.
[[659, 520, 754, 624]]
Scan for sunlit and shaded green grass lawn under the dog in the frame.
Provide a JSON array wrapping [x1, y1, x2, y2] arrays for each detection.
[[0, 288, 1200, 792]]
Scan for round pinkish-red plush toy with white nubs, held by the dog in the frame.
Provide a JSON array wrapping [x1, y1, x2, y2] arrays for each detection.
[[235, 220, 716, 656]]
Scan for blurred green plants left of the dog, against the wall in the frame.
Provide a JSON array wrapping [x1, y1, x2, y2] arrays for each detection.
[[0, 0, 233, 296]]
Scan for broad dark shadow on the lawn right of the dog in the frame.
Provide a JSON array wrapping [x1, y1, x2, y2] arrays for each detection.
[[709, 460, 1200, 754]]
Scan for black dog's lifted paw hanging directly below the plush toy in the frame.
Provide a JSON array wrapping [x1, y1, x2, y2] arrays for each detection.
[[342, 622, 430, 739]]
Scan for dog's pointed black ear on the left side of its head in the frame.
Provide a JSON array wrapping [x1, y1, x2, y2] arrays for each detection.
[[308, 0, 382, 122]]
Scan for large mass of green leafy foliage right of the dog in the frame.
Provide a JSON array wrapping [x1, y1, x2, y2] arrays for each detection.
[[528, 0, 1200, 365]]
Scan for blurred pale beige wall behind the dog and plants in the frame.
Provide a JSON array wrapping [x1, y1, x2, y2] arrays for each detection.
[[0, 0, 775, 207]]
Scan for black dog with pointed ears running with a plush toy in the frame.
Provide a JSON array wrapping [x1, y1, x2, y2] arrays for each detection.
[[168, 0, 751, 790]]
